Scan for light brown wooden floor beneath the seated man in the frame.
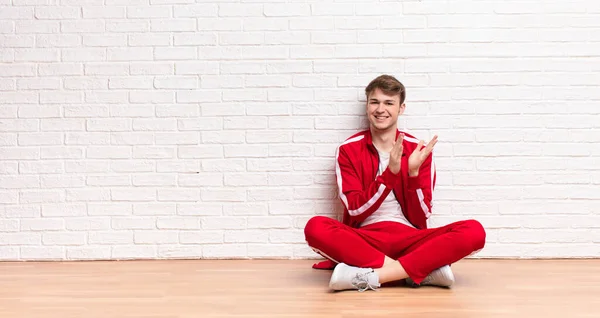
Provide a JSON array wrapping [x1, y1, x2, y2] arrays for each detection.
[[0, 260, 600, 318]]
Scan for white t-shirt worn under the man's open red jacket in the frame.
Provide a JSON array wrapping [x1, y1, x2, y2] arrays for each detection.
[[360, 149, 414, 228]]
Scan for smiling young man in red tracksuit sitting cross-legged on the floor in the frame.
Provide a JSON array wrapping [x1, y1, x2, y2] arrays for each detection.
[[304, 75, 486, 291]]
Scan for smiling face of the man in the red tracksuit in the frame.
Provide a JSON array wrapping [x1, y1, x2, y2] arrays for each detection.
[[367, 88, 405, 130]]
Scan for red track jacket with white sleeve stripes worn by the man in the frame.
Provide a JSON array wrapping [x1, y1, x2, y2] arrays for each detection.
[[336, 130, 436, 229]]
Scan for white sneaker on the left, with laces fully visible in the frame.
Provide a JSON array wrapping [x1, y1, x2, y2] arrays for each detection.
[[329, 263, 381, 292]]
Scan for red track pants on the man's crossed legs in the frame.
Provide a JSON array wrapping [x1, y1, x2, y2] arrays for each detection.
[[304, 216, 485, 284]]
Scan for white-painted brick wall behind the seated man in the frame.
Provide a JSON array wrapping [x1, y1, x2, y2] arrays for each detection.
[[0, 0, 600, 260]]
